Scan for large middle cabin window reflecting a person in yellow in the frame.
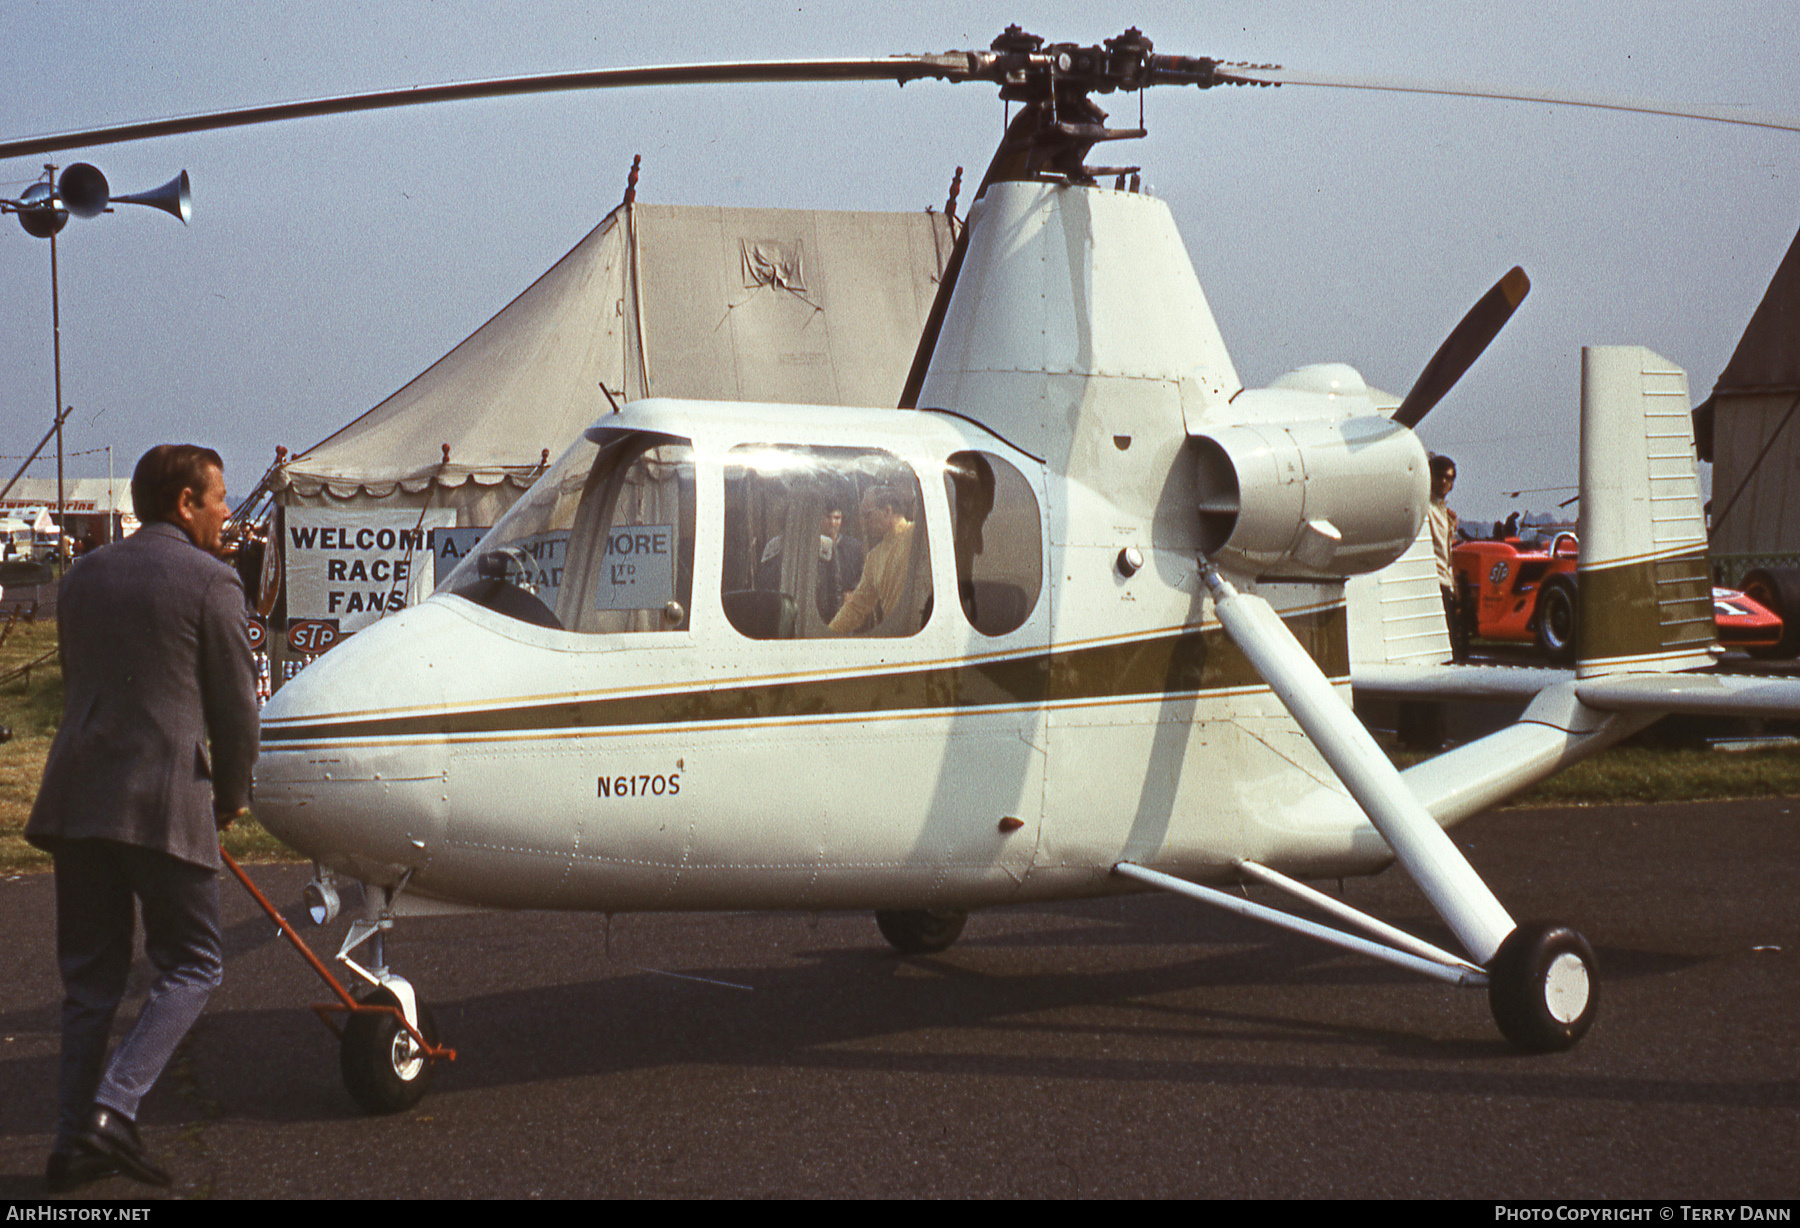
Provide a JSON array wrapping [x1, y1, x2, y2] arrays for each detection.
[[720, 445, 931, 639]]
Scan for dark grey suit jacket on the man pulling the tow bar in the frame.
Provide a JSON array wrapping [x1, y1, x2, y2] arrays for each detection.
[[25, 522, 257, 870]]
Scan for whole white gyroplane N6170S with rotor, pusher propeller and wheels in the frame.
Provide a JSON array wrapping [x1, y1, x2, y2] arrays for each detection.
[[0, 27, 1800, 1109]]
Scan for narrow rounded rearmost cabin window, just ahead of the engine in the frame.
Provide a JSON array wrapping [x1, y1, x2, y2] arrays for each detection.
[[943, 452, 1044, 636]]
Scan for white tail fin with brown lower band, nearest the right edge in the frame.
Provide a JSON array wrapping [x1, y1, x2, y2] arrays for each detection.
[[1575, 346, 1715, 679]]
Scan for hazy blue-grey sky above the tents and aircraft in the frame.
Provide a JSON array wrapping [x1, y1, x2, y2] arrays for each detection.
[[0, 0, 1800, 519]]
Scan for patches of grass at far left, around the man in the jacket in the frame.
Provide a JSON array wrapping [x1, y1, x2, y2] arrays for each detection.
[[0, 621, 302, 873]]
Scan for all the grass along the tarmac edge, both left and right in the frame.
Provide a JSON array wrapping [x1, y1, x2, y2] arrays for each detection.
[[0, 621, 1800, 873]]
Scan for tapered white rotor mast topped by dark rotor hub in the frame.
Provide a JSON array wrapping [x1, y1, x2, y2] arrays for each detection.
[[900, 27, 1240, 514]]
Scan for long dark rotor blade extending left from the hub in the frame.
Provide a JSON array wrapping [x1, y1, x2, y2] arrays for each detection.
[[0, 52, 995, 158]]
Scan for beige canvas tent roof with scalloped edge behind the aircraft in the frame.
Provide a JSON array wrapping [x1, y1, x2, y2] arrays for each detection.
[[272, 203, 950, 524]]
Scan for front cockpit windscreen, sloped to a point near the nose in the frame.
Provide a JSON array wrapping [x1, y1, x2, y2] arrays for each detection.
[[439, 429, 695, 634]]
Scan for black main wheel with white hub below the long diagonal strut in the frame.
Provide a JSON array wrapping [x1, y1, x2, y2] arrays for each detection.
[[1487, 922, 1600, 1053]]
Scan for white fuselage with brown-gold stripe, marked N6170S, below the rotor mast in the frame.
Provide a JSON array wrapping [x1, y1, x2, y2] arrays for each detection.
[[257, 392, 1390, 911]]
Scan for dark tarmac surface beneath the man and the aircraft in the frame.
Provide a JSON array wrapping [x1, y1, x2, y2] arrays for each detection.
[[0, 799, 1800, 1199]]
